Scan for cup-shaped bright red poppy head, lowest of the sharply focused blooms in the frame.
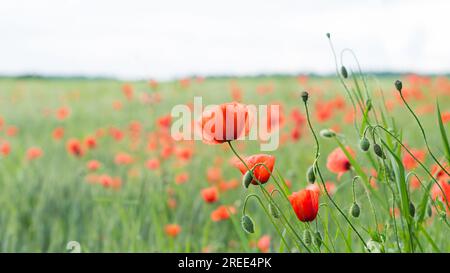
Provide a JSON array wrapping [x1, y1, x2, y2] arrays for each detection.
[[289, 189, 319, 222]]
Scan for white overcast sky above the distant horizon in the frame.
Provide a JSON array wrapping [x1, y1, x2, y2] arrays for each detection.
[[0, 0, 450, 79]]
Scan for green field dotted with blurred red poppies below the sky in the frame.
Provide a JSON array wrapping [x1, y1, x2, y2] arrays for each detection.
[[0, 76, 450, 252]]
